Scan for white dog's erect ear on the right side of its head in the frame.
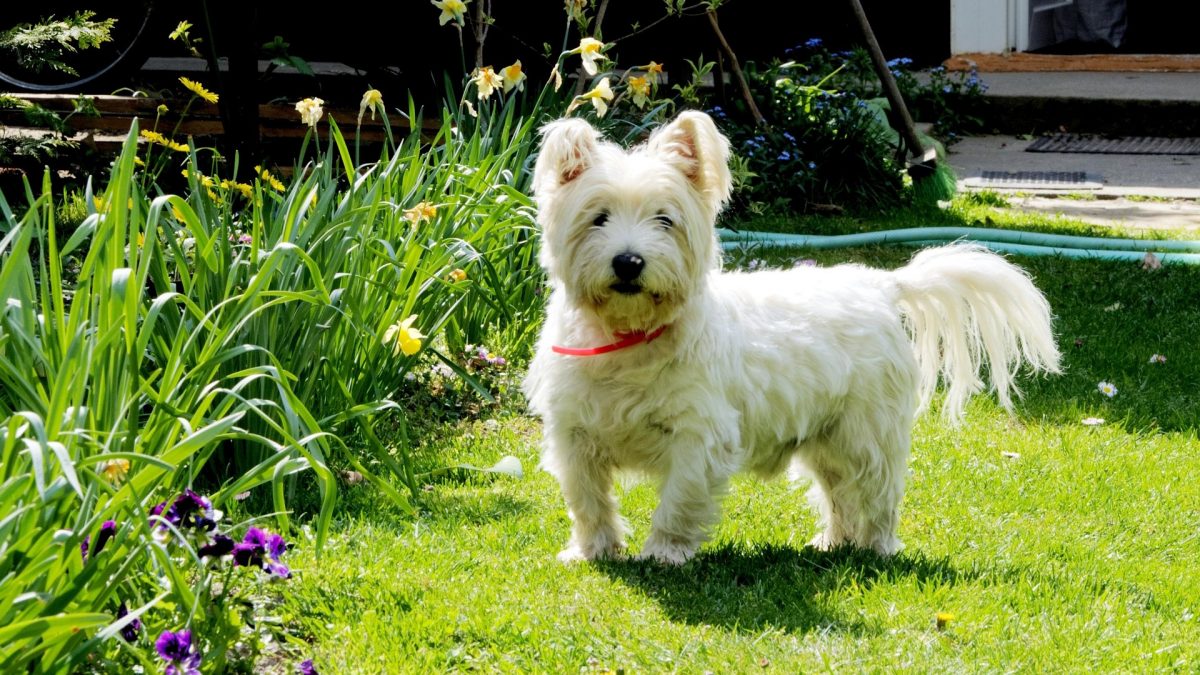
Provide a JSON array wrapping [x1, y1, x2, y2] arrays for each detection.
[[649, 110, 733, 213]]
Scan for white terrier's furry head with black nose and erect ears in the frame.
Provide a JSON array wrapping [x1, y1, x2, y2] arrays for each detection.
[[533, 112, 731, 330]]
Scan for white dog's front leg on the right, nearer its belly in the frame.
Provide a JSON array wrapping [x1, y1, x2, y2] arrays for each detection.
[[637, 443, 732, 565]]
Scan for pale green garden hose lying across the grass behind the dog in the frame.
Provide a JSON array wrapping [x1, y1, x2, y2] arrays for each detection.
[[718, 227, 1200, 264]]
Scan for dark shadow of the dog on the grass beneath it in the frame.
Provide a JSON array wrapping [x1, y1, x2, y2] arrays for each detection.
[[594, 544, 965, 635]]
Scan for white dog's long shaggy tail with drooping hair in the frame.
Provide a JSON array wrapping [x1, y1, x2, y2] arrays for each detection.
[[893, 244, 1058, 420]]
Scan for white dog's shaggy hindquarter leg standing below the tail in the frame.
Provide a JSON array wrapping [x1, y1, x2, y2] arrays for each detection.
[[798, 418, 908, 555]]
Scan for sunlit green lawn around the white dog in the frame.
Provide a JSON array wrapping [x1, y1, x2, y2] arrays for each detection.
[[276, 207, 1200, 673]]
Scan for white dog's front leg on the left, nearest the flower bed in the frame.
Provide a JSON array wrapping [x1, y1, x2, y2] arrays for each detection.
[[541, 431, 628, 562]]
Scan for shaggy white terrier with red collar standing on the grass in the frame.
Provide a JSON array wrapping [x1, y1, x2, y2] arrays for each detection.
[[524, 112, 1058, 565]]
